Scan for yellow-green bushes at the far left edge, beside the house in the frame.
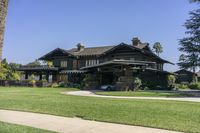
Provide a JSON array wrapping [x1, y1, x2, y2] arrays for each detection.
[[0, 59, 20, 80]]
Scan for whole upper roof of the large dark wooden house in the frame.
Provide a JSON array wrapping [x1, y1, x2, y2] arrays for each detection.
[[39, 43, 173, 64]]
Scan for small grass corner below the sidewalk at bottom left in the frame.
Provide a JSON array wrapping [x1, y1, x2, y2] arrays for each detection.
[[0, 122, 54, 133]]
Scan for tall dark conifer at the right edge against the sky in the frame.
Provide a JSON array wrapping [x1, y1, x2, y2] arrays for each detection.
[[178, 0, 200, 72]]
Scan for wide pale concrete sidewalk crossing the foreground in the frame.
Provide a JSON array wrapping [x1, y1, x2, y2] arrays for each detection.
[[0, 110, 181, 133]]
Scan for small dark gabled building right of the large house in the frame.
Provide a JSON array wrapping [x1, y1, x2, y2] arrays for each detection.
[[174, 69, 197, 83]]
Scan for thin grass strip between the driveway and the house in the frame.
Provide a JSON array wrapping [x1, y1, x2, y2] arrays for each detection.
[[96, 91, 190, 97]]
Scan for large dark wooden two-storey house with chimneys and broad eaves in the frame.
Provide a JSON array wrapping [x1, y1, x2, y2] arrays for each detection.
[[19, 38, 173, 88]]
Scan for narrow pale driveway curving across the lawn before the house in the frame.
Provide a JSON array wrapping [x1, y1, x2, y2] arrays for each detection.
[[62, 91, 200, 102]]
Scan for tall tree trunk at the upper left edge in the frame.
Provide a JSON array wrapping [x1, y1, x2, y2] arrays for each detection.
[[0, 0, 8, 62]]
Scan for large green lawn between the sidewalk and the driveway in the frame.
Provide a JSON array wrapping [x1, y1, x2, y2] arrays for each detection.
[[0, 88, 200, 133]]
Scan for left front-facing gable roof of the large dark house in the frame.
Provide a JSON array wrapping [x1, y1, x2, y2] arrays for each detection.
[[39, 48, 75, 60]]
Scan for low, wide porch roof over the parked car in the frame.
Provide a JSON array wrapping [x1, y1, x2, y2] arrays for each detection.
[[80, 60, 155, 70]]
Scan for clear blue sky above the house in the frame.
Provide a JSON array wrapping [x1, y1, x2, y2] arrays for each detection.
[[3, 0, 197, 71]]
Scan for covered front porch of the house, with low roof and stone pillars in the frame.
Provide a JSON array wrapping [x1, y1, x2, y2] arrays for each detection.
[[81, 60, 170, 90]]
